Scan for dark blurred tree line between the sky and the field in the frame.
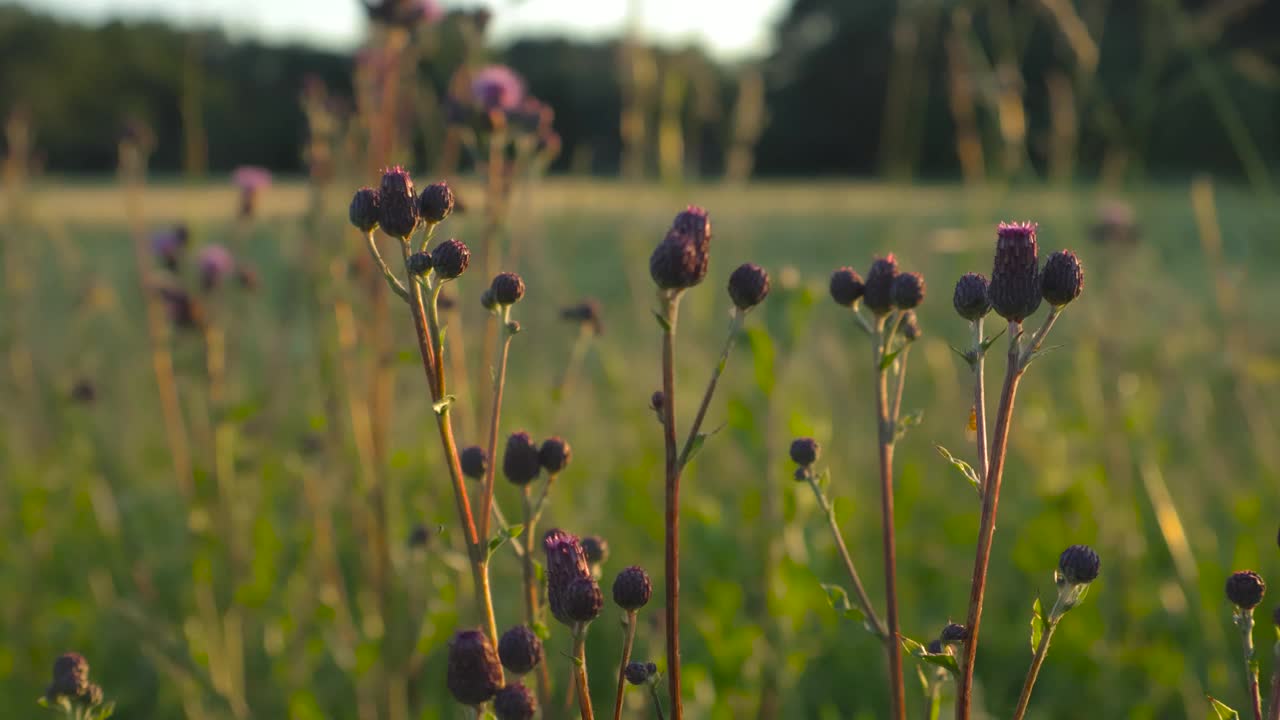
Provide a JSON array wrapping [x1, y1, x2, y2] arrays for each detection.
[[0, 0, 1280, 182]]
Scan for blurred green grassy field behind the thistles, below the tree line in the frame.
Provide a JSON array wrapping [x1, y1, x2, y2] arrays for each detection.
[[0, 178, 1280, 719]]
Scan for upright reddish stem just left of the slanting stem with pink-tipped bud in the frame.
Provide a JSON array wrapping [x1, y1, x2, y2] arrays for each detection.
[[872, 314, 906, 720]]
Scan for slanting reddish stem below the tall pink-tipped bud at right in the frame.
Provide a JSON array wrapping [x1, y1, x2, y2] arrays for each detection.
[[956, 322, 1023, 720]]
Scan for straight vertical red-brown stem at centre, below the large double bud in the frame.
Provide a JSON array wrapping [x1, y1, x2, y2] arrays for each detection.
[[662, 292, 684, 720]]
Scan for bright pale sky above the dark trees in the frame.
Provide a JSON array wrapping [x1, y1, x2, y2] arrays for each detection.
[[19, 0, 787, 58]]
